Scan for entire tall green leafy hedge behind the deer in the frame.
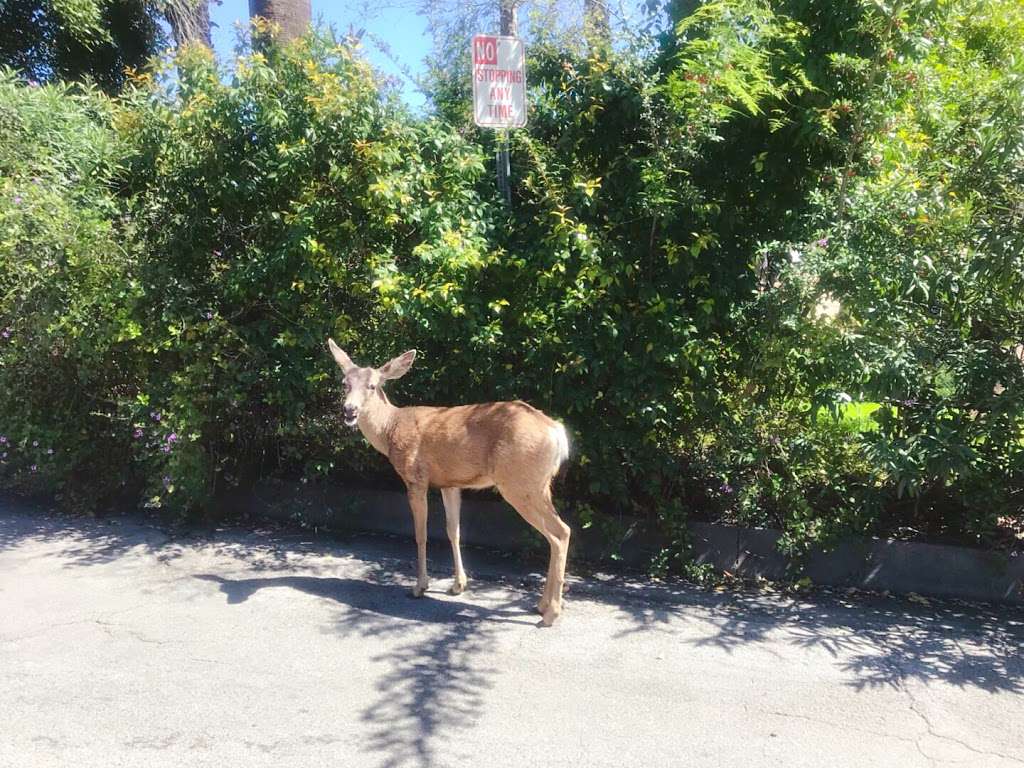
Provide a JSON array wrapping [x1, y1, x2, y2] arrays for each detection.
[[0, 0, 1024, 561]]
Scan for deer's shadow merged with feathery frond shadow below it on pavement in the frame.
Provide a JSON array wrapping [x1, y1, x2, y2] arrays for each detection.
[[196, 572, 538, 768]]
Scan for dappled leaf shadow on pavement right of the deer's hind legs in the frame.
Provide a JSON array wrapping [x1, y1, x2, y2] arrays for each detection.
[[569, 585, 1024, 693]]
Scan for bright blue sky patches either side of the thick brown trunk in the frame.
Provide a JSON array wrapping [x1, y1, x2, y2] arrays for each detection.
[[210, 0, 430, 108]]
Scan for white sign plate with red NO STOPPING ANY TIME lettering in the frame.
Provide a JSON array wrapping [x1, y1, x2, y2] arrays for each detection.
[[473, 35, 526, 128]]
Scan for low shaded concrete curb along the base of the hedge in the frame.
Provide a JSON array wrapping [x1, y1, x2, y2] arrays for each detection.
[[224, 482, 1024, 605]]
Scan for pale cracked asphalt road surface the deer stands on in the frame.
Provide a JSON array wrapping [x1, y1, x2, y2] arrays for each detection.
[[0, 502, 1024, 768]]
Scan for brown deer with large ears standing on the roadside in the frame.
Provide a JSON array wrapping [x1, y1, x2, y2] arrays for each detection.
[[328, 339, 571, 627]]
